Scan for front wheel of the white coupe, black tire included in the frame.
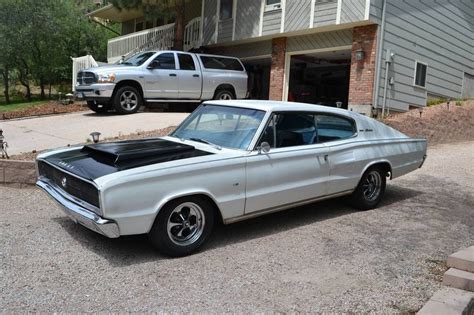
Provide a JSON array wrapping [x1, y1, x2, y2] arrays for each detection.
[[148, 197, 214, 257]]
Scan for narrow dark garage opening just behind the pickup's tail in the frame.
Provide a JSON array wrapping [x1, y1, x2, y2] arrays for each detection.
[[242, 57, 272, 100]]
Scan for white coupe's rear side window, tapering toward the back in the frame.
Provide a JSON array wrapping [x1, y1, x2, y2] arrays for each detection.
[[315, 114, 356, 143]]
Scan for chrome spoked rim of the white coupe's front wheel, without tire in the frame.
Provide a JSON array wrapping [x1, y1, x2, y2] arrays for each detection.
[[167, 202, 206, 246]]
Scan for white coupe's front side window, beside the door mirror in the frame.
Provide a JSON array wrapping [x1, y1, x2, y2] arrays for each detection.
[[260, 113, 316, 148]]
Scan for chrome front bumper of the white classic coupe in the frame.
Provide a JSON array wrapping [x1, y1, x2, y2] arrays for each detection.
[[36, 180, 120, 238]]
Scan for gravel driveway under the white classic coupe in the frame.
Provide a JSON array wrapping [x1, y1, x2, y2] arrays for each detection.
[[0, 142, 474, 313]]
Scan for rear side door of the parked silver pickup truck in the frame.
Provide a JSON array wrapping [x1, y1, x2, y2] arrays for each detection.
[[178, 53, 202, 100]]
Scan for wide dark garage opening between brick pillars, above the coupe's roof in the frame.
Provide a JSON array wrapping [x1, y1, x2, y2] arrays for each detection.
[[288, 50, 351, 109]]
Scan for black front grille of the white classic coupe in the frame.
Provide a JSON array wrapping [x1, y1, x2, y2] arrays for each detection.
[[38, 161, 99, 208]]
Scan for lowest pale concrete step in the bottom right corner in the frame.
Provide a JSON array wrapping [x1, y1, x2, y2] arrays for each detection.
[[417, 287, 474, 315]]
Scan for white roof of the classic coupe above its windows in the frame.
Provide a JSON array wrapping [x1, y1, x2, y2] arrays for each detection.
[[204, 100, 360, 116]]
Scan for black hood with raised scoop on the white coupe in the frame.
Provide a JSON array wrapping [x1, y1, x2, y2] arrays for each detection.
[[40, 138, 213, 180]]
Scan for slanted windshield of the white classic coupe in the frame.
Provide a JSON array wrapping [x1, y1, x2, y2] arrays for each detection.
[[171, 104, 265, 150]]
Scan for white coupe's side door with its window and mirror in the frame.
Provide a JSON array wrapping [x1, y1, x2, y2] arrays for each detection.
[[245, 112, 329, 214]]
